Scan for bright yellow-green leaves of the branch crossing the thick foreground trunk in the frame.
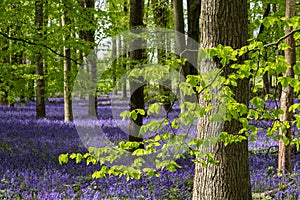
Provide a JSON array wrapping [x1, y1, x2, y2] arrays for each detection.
[[61, 12, 300, 179]]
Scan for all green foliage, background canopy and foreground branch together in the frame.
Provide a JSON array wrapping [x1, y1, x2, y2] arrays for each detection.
[[0, 0, 300, 184]]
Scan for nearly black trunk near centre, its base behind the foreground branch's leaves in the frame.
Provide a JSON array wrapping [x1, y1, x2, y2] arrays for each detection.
[[129, 0, 145, 150]]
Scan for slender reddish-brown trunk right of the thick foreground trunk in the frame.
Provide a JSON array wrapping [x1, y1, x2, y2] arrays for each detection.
[[278, 0, 296, 173]]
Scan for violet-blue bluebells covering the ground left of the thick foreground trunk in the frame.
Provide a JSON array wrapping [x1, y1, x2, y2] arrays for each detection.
[[0, 99, 193, 200]]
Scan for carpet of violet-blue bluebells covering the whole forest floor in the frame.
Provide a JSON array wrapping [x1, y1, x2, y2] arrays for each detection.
[[0, 98, 300, 200]]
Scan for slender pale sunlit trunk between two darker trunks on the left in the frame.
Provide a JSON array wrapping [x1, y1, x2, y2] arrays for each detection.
[[61, 2, 73, 122]]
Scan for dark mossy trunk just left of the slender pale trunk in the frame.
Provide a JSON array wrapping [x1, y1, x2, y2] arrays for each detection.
[[35, 0, 46, 119]]
